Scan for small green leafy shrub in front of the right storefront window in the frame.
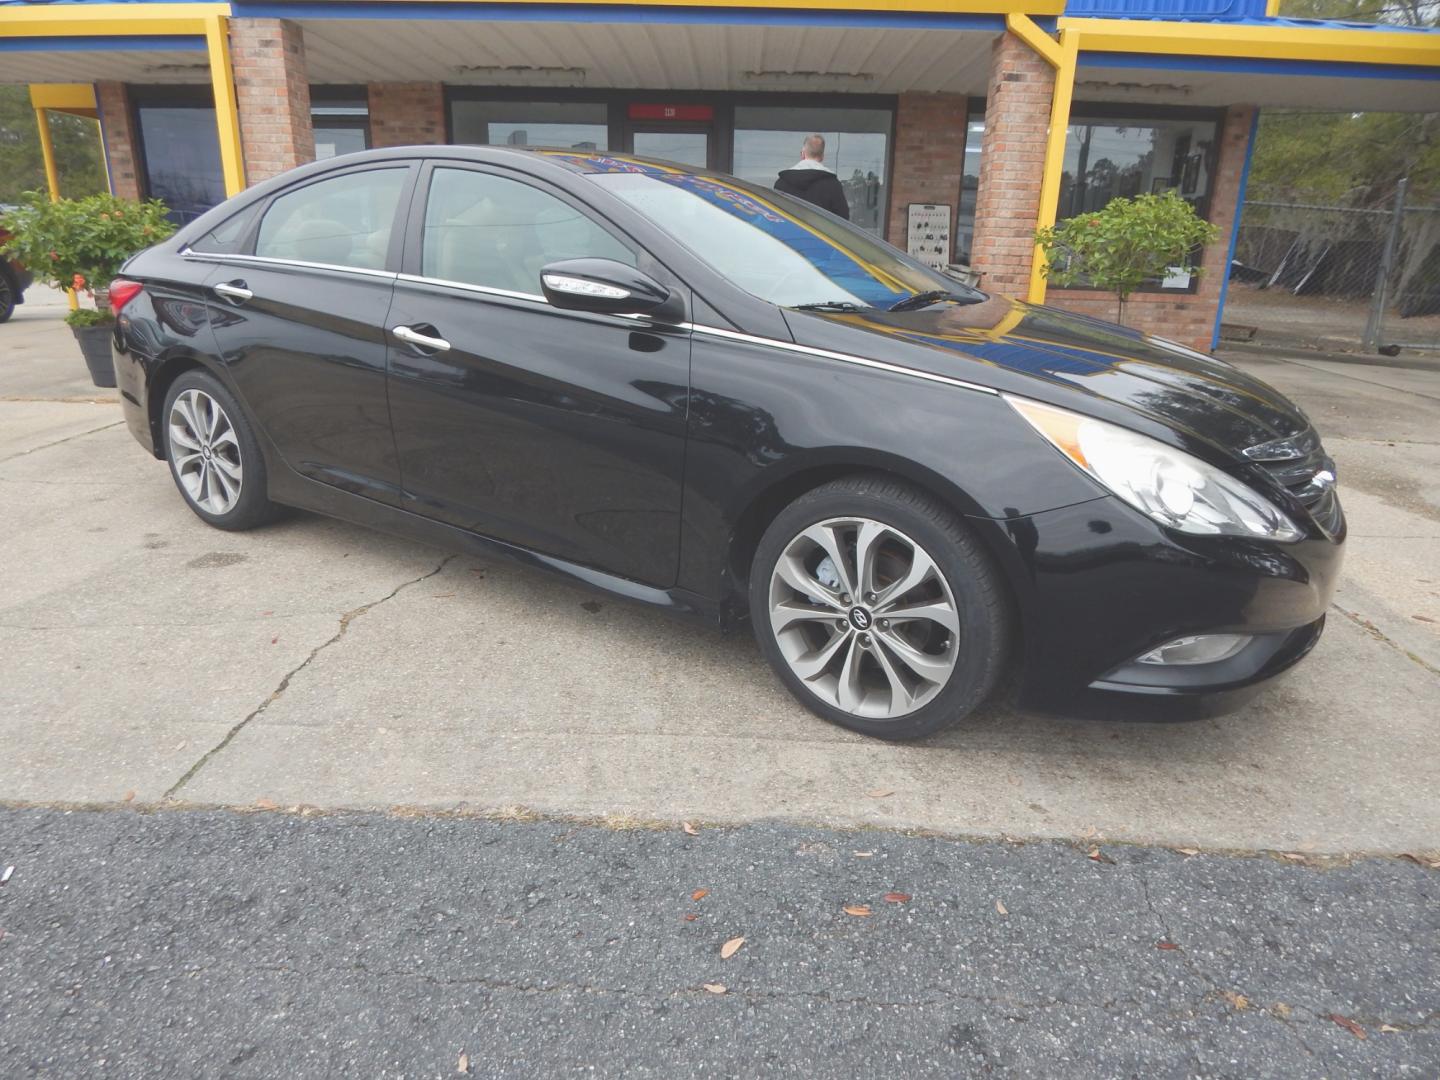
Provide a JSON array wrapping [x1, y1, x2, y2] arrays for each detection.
[[1035, 192, 1218, 323]]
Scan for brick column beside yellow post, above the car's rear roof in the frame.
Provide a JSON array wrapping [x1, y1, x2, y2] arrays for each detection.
[[230, 19, 315, 184]]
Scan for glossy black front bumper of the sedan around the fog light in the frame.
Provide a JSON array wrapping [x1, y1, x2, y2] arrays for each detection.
[[982, 497, 1345, 719]]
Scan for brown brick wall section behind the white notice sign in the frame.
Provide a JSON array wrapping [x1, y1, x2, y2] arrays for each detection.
[[886, 94, 969, 258]]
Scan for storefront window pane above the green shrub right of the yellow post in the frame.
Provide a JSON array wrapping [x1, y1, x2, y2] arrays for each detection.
[[1058, 120, 1217, 219]]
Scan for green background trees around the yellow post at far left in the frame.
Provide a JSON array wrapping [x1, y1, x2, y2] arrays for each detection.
[[0, 86, 108, 203]]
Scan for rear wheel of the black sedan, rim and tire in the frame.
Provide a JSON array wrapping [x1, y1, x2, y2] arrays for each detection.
[[161, 370, 276, 531]]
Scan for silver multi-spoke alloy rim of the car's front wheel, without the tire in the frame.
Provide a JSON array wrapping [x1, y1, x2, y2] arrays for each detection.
[[769, 517, 960, 720]]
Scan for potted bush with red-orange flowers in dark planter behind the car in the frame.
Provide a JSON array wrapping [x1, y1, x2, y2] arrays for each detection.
[[0, 192, 174, 386]]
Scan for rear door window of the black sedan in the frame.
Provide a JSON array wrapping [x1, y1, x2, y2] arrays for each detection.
[[255, 168, 406, 269]]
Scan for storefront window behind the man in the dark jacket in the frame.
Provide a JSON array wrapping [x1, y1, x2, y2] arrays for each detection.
[[730, 105, 890, 233]]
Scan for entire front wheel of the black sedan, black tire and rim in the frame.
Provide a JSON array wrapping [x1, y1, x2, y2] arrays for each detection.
[[750, 475, 1012, 740]]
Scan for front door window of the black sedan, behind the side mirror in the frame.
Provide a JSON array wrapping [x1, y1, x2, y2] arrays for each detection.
[[420, 168, 635, 295]]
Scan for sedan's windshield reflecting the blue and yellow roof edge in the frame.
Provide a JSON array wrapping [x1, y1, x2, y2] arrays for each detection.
[[590, 158, 985, 308]]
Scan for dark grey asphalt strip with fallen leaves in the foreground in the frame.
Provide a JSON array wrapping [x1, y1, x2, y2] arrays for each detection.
[[0, 809, 1440, 1080]]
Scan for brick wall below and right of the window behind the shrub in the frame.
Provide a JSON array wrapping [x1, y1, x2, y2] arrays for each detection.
[[1045, 105, 1256, 351]]
